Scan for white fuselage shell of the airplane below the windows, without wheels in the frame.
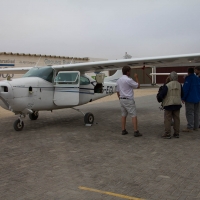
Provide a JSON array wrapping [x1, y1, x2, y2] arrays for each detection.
[[0, 75, 116, 114]]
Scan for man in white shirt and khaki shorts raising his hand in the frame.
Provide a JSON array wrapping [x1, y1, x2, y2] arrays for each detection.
[[117, 66, 142, 137]]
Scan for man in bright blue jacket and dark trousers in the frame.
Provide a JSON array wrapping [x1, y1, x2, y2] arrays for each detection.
[[182, 68, 200, 132]]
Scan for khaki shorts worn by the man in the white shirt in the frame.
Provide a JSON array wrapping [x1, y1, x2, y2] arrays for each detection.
[[120, 99, 137, 117]]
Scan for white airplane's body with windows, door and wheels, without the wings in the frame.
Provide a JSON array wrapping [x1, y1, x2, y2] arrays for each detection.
[[0, 66, 121, 131]]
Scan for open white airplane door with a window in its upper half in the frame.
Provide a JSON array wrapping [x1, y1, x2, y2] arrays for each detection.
[[54, 71, 80, 106]]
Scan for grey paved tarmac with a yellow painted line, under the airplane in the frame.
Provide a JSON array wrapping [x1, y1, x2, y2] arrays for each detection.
[[0, 87, 200, 200]]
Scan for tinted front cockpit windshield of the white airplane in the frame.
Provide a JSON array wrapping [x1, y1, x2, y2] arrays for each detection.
[[22, 67, 53, 83]]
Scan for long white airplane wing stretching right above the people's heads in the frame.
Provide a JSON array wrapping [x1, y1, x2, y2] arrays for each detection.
[[52, 53, 200, 72]]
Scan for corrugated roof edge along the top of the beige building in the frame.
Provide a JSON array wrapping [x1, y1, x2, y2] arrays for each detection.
[[0, 52, 89, 60]]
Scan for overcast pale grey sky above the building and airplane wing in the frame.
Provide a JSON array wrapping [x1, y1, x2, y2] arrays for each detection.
[[0, 0, 200, 60]]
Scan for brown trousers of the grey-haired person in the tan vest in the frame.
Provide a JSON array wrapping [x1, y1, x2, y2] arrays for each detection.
[[164, 109, 180, 135]]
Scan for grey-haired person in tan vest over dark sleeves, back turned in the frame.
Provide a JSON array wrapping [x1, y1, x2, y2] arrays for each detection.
[[161, 71, 183, 139]]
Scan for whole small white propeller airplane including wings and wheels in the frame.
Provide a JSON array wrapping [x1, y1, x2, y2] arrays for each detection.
[[0, 53, 200, 131]]
